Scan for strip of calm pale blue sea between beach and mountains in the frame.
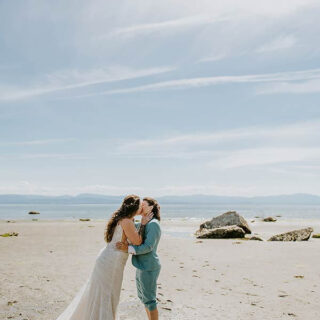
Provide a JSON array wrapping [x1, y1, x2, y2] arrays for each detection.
[[0, 204, 320, 220]]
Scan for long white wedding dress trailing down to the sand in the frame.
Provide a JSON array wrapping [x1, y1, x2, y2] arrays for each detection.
[[57, 225, 128, 320]]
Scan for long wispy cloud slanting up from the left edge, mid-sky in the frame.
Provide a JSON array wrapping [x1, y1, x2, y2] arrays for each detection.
[[0, 66, 174, 101]]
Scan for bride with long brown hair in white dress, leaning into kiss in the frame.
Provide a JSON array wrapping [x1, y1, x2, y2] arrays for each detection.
[[57, 195, 152, 320]]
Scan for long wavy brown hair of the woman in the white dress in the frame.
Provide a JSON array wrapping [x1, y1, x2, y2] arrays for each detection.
[[104, 194, 140, 242]]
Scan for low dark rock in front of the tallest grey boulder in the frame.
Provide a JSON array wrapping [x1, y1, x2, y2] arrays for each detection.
[[196, 226, 245, 239]]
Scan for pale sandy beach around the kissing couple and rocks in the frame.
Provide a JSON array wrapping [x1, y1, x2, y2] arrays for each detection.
[[0, 218, 320, 320]]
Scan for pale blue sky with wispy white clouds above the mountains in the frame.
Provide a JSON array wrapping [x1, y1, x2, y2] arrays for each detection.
[[0, 0, 320, 196]]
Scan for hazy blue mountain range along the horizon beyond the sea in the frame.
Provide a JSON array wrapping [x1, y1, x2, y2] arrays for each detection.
[[0, 193, 320, 205]]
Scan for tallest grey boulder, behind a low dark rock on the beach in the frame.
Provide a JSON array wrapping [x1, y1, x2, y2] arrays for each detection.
[[199, 211, 251, 233]]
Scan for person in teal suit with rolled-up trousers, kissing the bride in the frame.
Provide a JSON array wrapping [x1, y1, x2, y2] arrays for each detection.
[[117, 198, 161, 320]]
